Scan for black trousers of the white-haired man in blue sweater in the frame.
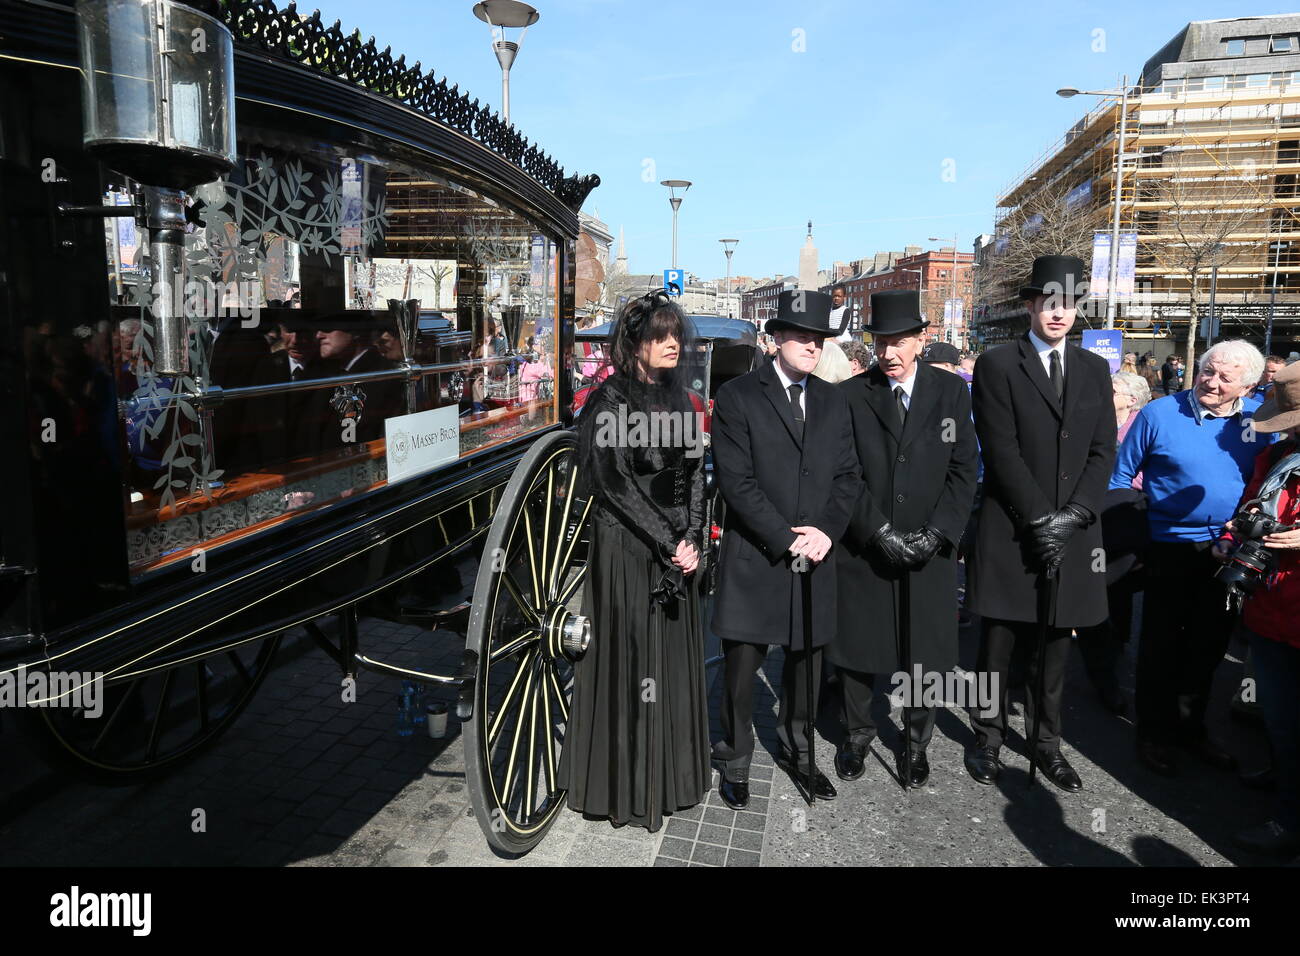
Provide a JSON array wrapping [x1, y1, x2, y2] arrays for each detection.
[[1135, 541, 1232, 745]]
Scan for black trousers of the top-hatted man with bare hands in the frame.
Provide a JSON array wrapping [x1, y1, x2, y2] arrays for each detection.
[[714, 641, 822, 782]]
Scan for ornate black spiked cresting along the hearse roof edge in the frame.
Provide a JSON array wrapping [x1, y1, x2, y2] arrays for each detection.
[[221, 0, 601, 212]]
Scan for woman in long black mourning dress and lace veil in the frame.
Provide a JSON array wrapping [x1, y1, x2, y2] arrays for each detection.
[[560, 291, 711, 832]]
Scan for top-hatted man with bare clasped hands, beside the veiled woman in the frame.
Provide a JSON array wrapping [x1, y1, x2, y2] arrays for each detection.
[[712, 290, 862, 809]]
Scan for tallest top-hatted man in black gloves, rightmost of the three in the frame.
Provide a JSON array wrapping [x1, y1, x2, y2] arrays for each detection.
[[966, 255, 1115, 792]]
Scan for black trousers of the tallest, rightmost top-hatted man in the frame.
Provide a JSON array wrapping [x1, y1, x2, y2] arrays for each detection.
[[971, 618, 1070, 754]]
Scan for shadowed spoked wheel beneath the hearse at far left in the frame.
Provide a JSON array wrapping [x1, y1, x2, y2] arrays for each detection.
[[29, 633, 282, 784]]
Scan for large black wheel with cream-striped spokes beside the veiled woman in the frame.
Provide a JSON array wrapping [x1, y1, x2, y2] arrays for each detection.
[[465, 432, 592, 853]]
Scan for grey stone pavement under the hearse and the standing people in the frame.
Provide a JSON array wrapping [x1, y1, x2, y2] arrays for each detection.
[[0, 582, 1269, 866]]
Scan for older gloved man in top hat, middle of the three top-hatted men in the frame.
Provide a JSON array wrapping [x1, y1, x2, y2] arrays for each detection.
[[828, 291, 976, 787]]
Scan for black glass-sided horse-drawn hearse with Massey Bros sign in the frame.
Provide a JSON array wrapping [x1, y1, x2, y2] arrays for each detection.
[[0, 0, 598, 851]]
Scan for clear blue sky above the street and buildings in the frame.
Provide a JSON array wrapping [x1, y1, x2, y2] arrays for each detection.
[[314, 0, 1288, 278]]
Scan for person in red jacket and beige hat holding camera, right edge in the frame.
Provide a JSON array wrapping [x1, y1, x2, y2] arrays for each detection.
[[1214, 363, 1300, 857]]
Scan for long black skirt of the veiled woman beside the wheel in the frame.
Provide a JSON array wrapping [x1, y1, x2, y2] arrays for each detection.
[[559, 511, 711, 832]]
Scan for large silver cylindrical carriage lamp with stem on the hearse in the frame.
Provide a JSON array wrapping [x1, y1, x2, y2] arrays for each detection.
[[77, 0, 235, 375]]
